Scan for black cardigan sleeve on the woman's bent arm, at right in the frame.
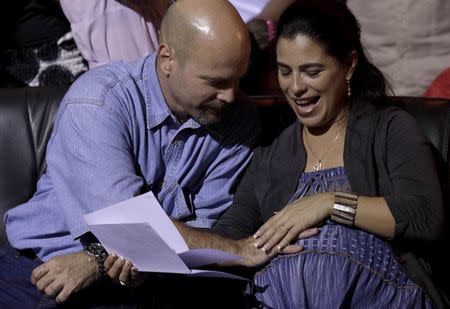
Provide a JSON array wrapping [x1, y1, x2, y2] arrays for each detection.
[[379, 111, 444, 241]]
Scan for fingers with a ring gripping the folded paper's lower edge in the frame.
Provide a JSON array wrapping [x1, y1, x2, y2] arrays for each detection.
[[105, 254, 147, 288]]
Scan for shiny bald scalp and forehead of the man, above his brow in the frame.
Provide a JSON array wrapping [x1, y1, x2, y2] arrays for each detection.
[[160, 0, 249, 63]]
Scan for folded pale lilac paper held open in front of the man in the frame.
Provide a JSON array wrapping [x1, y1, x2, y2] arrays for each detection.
[[84, 192, 244, 279]]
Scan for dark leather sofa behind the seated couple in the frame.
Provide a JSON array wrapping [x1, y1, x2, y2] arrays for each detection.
[[0, 88, 450, 296]]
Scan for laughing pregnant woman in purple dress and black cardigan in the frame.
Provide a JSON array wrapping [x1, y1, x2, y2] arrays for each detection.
[[210, 0, 445, 308]]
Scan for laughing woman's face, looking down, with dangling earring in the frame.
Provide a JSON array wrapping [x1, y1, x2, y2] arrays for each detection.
[[277, 35, 356, 128]]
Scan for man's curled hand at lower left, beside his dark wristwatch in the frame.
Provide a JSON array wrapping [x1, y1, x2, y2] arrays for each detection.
[[31, 252, 98, 303]]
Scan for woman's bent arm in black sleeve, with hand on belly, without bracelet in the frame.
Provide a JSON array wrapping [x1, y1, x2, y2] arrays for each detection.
[[255, 108, 443, 250]]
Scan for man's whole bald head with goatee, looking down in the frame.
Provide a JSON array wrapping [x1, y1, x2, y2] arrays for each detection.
[[156, 0, 250, 125]]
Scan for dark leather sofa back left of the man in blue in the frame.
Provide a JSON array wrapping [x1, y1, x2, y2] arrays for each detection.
[[0, 88, 67, 244]]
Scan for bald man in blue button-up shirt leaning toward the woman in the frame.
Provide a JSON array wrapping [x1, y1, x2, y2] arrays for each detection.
[[0, 0, 258, 308]]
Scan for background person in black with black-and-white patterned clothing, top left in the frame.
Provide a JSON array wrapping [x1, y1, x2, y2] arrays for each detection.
[[0, 0, 87, 87]]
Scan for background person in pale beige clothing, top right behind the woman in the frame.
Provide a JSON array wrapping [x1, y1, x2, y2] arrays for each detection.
[[347, 0, 450, 96]]
